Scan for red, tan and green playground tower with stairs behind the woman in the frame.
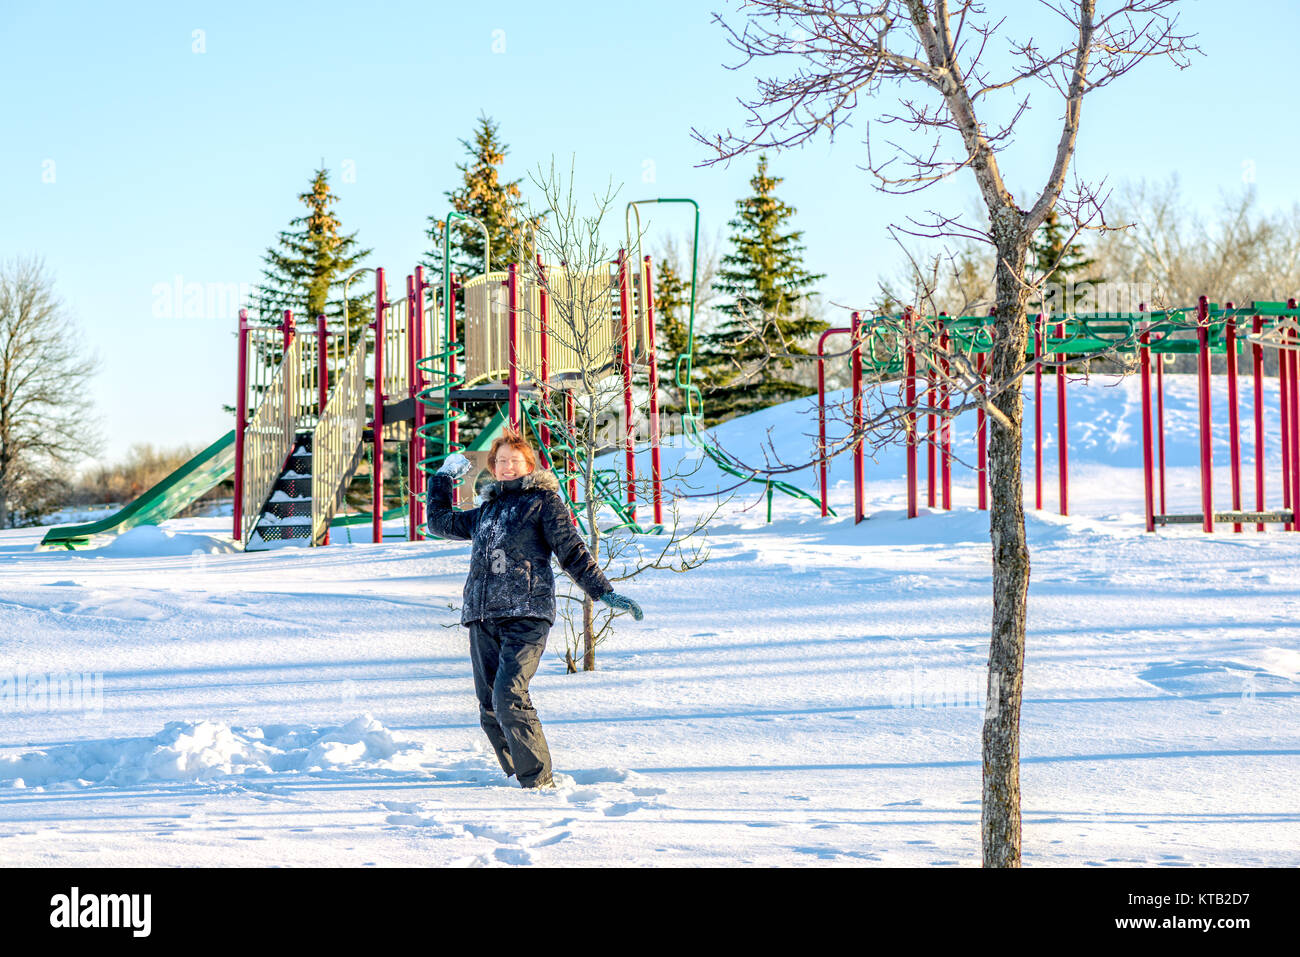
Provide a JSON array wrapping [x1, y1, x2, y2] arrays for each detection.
[[205, 199, 832, 550]]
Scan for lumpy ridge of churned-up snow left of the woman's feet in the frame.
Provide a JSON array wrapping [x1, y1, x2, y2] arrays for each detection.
[[0, 714, 420, 788]]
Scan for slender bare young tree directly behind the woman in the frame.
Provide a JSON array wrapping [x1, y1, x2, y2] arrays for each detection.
[[515, 160, 723, 672]]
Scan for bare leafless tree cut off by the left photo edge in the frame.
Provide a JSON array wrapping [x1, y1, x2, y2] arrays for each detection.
[[0, 259, 99, 528]]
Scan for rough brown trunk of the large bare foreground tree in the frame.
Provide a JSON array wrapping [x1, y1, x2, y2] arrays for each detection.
[[980, 209, 1030, 867]]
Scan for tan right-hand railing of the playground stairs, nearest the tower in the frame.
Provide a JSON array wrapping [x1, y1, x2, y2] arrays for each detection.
[[312, 339, 365, 544]]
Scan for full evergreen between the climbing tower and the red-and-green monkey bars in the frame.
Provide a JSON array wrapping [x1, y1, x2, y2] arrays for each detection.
[[698, 156, 828, 425]]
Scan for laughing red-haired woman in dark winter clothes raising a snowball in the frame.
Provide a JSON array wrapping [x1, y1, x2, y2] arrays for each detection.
[[428, 433, 642, 788]]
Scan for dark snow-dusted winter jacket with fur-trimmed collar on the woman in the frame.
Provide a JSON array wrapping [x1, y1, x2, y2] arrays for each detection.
[[428, 468, 612, 624]]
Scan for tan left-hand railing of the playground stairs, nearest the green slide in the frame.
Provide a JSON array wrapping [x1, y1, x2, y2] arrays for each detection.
[[239, 335, 315, 541]]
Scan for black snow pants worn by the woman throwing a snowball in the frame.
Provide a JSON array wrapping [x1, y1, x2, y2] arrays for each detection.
[[469, 618, 551, 788]]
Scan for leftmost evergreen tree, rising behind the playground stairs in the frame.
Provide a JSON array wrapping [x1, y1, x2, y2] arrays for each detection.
[[250, 169, 374, 342]]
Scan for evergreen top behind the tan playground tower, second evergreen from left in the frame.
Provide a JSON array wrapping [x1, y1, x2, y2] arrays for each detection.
[[424, 114, 536, 282]]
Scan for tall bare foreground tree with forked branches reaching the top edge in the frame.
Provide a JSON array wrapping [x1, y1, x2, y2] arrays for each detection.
[[694, 0, 1196, 867]]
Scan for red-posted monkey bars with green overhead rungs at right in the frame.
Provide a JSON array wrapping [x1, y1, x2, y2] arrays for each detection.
[[818, 296, 1300, 532]]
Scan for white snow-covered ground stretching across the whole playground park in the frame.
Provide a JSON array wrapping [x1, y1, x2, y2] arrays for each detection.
[[0, 377, 1300, 866]]
